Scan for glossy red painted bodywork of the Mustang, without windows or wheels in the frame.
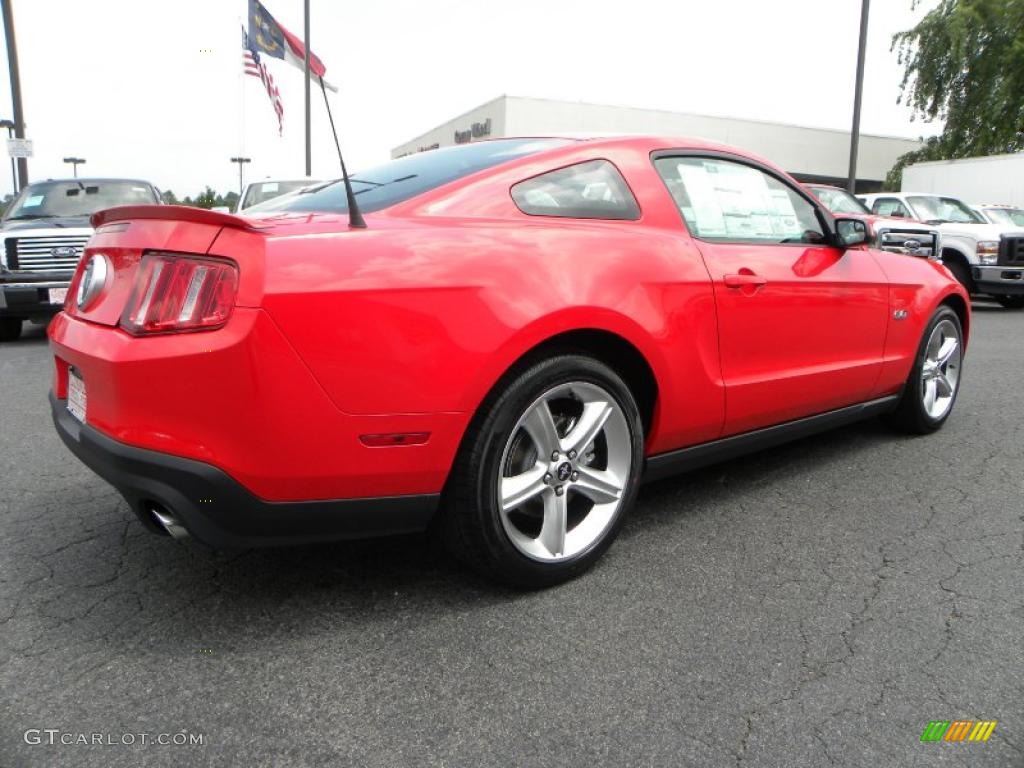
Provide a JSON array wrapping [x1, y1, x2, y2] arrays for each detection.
[[50, 138, 967, 501]]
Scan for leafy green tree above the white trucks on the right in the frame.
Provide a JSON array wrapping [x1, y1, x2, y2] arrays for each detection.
[[886, 0, 1024, 188]]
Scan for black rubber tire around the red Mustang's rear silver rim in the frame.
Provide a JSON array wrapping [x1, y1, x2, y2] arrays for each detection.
[[440, 353, 643, 589]]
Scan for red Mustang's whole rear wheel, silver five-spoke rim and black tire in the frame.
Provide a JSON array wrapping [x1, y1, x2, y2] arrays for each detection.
[[442, 354, 643, 588]]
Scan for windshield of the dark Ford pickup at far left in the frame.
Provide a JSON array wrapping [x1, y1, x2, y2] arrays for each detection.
[[3, 179, 160, 221]]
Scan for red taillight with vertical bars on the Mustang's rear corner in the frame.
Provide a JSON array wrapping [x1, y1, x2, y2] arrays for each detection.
[[121, 253, 239, 335]]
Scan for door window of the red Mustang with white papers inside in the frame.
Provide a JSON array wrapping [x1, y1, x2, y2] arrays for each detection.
[[654, 158, 826, 243]]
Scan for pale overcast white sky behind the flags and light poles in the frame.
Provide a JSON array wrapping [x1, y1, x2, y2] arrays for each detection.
[[0, 0, 941, 198]]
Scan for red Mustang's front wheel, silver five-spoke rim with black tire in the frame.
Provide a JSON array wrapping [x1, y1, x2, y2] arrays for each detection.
[[891, 305, 964, 434]]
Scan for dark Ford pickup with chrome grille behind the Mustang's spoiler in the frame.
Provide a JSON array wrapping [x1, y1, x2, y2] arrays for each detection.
[[0, 178, 161, 341]]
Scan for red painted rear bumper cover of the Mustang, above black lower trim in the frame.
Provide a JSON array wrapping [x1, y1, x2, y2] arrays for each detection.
[[49, 307, 469, 503]]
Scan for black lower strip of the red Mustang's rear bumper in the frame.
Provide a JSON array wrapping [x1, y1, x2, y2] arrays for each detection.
[[50, 392, 439, 548]]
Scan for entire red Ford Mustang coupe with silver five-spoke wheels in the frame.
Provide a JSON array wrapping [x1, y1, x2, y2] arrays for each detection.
[[50, 138, 970, 586]]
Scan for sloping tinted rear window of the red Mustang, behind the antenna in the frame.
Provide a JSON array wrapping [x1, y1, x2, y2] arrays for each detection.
[[246, 138, 568, 214]]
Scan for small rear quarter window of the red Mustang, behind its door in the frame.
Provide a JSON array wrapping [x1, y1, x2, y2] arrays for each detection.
[[512, 160, 640, 220]]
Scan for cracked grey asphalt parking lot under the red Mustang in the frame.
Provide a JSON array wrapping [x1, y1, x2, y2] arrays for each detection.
[[0, 303, 1024, 768]]
